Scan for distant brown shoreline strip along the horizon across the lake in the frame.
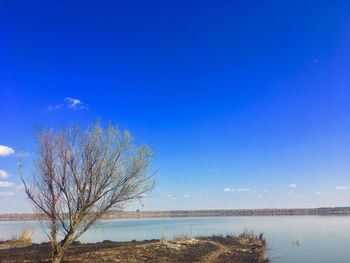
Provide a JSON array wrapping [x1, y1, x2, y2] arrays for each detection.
[[0, 207, 350, 221]]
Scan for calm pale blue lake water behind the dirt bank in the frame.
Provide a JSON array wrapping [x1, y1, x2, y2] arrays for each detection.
[[0, 216, 350, 263]]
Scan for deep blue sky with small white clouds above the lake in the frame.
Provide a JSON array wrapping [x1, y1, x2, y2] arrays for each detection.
[[0, 1, 350, 213]]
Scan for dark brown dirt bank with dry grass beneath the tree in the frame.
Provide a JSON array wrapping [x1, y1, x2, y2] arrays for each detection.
[[0, 237, 268, 263]]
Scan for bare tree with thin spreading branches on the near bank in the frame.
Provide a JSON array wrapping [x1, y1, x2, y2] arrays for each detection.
[[22, 123, 154, 263]]
